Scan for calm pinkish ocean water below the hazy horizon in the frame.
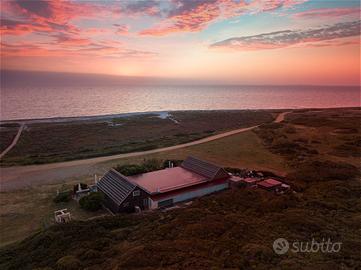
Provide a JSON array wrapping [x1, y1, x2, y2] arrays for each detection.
[[0, 85, 360, 120]]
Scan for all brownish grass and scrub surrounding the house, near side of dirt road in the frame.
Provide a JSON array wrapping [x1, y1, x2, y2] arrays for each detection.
[[0, 108, 361, 269]]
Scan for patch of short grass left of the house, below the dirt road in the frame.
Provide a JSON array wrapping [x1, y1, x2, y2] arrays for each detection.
[[0, 178, 107, 246]]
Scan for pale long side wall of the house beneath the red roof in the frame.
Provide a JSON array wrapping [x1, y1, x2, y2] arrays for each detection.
[[150, 182, 229, 209]]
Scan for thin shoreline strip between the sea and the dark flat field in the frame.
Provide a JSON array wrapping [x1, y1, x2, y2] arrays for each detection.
[[0, 105, 361, 124]]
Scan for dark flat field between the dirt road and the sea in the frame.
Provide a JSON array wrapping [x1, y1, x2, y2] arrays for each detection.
[[0, 111, 273, 166]]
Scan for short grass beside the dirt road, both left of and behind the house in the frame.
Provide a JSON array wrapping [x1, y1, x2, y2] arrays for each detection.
[[0, 131, 286, 245]]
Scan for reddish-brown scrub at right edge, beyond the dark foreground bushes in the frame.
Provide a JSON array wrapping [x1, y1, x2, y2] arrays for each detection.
[[255, 109, 361, 167]]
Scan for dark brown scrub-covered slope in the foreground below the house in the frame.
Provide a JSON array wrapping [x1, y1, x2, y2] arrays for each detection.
[[0, 163, 361, 269]]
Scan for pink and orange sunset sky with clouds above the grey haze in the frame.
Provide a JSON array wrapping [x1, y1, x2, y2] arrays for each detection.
[[1, 0, 360, 85]]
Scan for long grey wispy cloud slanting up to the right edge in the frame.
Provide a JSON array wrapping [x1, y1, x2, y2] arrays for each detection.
[[211, 21, 361, 50]]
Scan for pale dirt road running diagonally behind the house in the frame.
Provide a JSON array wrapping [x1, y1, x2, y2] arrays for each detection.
[[0, 112, 289, 191]]
